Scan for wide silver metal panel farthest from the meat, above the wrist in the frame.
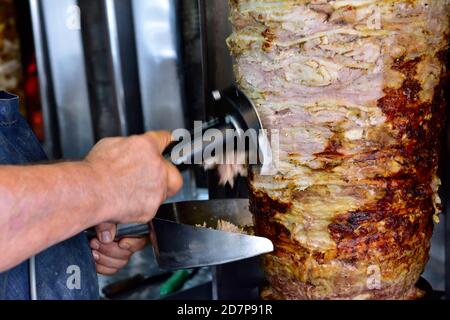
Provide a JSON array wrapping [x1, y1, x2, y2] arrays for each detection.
[[39, 0, 94, 159]]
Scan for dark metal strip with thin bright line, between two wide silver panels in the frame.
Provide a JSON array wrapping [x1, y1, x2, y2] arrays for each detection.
[[78, 0, 143, 141]]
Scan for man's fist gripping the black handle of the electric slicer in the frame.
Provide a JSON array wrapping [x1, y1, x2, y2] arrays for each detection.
[[85, 132, 183, 223]]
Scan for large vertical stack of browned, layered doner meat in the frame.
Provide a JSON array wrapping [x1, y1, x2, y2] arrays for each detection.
[[228, 0, 449, 299]]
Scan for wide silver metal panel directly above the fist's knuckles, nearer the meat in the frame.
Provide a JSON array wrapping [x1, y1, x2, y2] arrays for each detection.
[[131, 0, 186, 130]]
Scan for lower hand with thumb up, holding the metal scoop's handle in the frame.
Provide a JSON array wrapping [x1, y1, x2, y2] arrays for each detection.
[[90, 223, 148, 276]]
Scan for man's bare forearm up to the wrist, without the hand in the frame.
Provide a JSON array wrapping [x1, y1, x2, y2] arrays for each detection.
[[0, 162, 113, 272]]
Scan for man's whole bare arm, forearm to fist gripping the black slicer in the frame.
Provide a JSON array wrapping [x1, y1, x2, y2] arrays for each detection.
[[0, 132, 183, 272]]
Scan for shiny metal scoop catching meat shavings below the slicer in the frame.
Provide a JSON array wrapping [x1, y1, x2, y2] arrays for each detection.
[[112, 199, 273, 270]]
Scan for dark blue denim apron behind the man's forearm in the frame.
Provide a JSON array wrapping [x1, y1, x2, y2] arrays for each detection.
[[0, 91, 99, 300]]
